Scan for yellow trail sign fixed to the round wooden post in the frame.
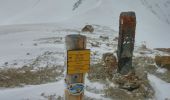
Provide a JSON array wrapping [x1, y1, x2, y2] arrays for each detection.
[[67, 49, 90, 74]]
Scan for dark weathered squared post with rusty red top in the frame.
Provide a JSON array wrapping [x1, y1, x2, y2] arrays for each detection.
[[117, 12, 136, 75]]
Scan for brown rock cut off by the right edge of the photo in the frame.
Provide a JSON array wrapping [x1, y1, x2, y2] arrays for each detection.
[[155, 56, 170, 70]]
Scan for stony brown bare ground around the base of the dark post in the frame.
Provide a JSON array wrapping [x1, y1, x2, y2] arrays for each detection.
[[87, 57, 156, 100]]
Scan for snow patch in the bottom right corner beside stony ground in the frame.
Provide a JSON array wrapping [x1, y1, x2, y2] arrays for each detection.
[[148, 74, 170, 100]]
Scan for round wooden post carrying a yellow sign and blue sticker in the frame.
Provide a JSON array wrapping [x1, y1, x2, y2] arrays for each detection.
[[65, 34, 90, 100]]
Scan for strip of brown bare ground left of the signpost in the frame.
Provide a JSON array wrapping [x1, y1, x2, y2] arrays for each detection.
[[0, 66, 63, 87]]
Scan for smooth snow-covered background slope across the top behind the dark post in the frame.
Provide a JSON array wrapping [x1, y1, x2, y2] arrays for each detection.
[[0, 0, 170, 47]]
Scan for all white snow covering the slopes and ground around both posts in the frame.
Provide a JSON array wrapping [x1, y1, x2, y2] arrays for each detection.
[[0, 0, 170, 100]]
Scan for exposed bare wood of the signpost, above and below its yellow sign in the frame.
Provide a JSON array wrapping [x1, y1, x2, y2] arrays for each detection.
[[65, 35, 86, 100]]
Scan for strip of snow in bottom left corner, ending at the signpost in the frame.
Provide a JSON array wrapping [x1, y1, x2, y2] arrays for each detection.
[[0, 80, 65, 100]]
